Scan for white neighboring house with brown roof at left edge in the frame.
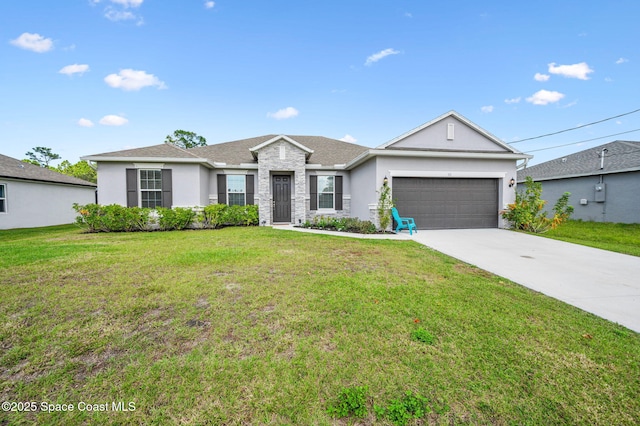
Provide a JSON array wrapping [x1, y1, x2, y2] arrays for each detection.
[[0, 151, 96, 229]]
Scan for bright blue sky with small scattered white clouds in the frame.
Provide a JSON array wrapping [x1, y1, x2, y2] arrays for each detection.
[[0, 0, 640, 164]]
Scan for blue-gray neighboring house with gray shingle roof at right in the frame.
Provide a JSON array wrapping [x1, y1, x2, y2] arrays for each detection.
[[518, 141, 640, 223]]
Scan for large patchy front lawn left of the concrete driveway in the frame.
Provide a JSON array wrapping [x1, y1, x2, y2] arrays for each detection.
[[0, 227, 640, 425]]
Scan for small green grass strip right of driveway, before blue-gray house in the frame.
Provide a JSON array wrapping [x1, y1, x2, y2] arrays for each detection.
[[540, 220, 640, 256]]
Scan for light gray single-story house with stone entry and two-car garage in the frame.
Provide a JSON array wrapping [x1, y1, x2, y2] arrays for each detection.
[[82, 111, 531, 229]]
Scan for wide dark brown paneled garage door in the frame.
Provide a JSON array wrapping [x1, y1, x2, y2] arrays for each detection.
[[393, 178, 498, 229]]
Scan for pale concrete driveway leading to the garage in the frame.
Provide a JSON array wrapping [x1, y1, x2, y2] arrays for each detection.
[[411, 229, 640, 333]]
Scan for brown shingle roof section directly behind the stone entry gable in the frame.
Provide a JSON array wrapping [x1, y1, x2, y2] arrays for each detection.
[[189, 135, 369, 166]]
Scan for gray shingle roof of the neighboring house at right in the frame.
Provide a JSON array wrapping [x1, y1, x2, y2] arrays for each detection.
[[518, 141, 640, 181]]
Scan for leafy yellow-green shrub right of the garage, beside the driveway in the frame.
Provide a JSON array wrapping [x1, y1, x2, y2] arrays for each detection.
[[501, 176, 573, 233]]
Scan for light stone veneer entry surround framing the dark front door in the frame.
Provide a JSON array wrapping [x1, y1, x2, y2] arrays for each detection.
[[255, 140, 306, 225]]
